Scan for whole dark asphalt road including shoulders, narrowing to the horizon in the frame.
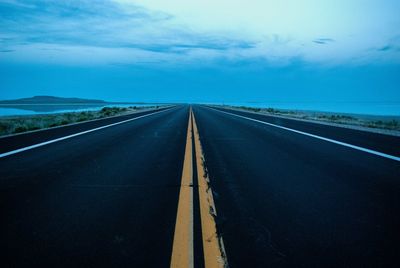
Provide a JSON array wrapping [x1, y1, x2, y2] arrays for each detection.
[[0, 105, 400, 267]]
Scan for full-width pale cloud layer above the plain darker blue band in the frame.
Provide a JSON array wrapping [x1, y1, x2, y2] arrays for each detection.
[[0, 0, 398, 64]]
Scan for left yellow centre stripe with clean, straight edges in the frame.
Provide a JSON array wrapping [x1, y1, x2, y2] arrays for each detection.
[[170, 110, 193, 268]]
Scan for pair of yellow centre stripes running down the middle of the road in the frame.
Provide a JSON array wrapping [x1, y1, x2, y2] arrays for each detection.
[[171, 109, 227, 268]]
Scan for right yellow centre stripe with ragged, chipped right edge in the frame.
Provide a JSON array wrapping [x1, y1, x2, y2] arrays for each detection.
[[191, 112, 228, 268]]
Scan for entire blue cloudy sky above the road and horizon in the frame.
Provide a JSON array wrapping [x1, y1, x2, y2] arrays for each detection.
[[0, 0, 400, 115]]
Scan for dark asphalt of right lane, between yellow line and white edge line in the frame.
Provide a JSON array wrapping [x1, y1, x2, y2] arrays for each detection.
[[194, 107, 400, 267]]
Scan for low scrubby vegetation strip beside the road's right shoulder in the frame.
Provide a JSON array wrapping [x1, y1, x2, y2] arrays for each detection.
[[230, 106, 400, 131]]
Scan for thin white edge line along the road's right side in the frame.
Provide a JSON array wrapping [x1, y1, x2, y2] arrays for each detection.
[[207, 107, 400, 162]]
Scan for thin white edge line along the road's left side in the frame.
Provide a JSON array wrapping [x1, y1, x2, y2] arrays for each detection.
[[0, 108, 173, 158]]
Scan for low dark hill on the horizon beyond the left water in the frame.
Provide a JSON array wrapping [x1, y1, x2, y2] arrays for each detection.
[[0, 96, 107, 105]]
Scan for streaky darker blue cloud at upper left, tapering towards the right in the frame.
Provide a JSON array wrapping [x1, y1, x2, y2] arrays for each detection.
[[0, 0, 255, 54]]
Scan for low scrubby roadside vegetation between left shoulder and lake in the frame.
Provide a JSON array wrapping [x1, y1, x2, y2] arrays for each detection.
[[0, 106, 158, 136]]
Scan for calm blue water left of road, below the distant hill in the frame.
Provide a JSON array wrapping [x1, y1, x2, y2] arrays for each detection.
[[0, 104, 153, 116]]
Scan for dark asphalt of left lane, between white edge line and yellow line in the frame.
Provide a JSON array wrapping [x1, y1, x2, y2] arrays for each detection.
[[0, 107, 189, 267]]
